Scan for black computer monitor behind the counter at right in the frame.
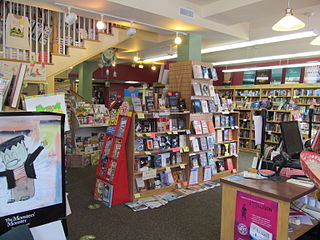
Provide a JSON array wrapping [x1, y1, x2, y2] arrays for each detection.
[[280, 121, 303, 158]]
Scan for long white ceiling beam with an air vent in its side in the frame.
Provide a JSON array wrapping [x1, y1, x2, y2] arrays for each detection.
[[108, 0, 250, 39]]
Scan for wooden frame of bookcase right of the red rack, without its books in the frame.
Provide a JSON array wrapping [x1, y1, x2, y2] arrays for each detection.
[[126, 111, 190, 201]]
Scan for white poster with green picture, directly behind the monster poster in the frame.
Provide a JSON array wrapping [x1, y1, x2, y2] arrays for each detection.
[[24, 93, 70, 131]]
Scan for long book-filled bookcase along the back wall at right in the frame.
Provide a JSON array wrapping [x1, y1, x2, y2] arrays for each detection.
[[217, 84, 320, 152]]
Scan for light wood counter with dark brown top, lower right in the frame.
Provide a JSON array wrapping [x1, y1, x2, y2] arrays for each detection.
[[220, 178, 318, 240]]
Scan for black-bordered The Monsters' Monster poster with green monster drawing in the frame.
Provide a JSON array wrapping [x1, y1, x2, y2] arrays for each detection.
[[0, 112, 66, 235]]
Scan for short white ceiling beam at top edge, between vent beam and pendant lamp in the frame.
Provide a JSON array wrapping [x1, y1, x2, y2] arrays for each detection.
[[200, 0, 263, 18]]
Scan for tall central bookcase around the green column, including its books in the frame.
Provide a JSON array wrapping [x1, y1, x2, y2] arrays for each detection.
[[168, 61, 239, 185]]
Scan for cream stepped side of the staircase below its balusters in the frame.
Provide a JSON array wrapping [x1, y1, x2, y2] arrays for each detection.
[[46, 28, 128, 93]]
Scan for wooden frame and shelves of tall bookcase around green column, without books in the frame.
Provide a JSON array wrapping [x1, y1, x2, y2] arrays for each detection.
[[168, 61, 239, 183]]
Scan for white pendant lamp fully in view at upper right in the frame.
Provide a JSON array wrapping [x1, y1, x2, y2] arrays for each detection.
[[272, 0, 305, 32]]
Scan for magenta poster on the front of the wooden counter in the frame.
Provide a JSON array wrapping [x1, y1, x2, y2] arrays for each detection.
[[234, 191, 278, 240]]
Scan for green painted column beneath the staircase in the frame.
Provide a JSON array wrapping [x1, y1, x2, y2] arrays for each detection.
[[78, 62, 96, 102]]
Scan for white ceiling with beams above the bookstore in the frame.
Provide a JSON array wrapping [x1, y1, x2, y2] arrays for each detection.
[[35, 0, 320, 65]]
